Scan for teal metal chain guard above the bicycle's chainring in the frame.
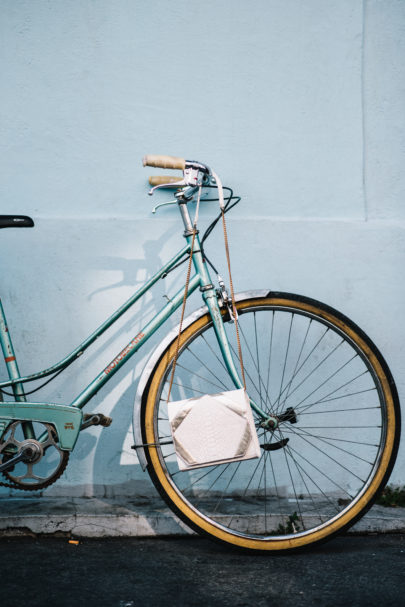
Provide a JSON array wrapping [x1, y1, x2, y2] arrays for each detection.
[[0, 402, 83, 451]]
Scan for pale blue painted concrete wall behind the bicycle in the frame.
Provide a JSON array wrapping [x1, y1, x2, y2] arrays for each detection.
[[0, 0, 405, 495]]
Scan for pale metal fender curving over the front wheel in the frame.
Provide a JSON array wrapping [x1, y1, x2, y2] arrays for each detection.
[[132, 289, 270, 471]]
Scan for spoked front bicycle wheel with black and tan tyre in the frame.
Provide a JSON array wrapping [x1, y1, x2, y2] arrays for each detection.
[[142, 293, 400, 551]]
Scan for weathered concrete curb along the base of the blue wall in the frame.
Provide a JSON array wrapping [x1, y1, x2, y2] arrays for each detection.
[[0, 497, 405, 537]]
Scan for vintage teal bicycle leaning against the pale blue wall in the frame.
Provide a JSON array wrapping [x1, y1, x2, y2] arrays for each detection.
[[0, 155, 400, 552]]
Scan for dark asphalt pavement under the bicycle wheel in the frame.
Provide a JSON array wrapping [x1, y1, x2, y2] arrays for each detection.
[[0, 534, 405, 607]]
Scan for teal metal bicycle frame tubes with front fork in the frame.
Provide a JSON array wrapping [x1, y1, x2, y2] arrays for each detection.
[[0, 211, 268, 437]]
